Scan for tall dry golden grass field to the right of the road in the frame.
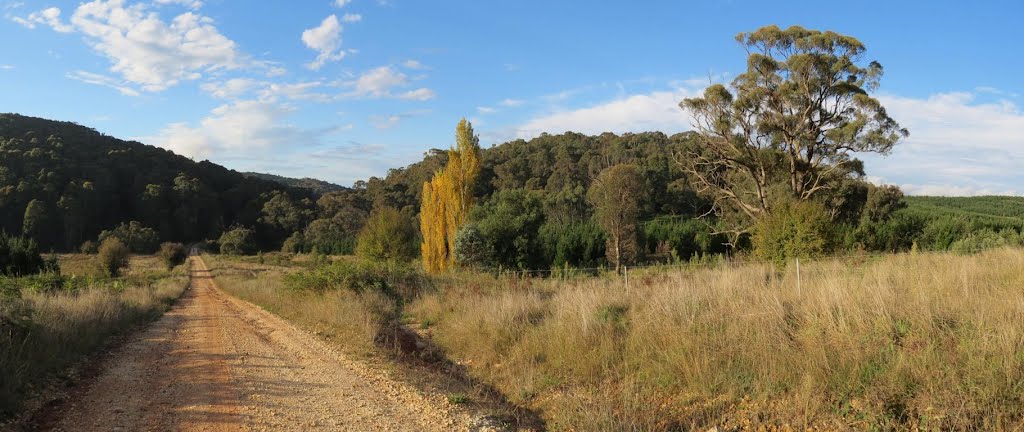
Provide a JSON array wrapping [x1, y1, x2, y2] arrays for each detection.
[[408, 249, 1024, 431]]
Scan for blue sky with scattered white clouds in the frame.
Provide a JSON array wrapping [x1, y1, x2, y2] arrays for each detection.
[[0, 0, 1024, 196]]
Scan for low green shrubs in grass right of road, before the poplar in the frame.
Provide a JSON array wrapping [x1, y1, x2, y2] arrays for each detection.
[[285, 260, 426, 300]]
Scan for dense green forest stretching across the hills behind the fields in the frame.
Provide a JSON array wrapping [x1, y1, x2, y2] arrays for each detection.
[[0, 115, 1024, 268]]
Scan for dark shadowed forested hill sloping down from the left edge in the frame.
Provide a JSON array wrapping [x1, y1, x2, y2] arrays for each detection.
[[0, 114, 312, 251]]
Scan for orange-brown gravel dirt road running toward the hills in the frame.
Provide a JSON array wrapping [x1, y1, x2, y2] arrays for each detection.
[[39, 257, 470, 431]]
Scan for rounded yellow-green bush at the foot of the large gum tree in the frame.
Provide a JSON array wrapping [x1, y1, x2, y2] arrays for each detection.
[[752, 201, 833, 264]]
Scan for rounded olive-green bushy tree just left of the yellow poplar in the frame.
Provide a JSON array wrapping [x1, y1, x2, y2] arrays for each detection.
[[355, 207, 418, 262]]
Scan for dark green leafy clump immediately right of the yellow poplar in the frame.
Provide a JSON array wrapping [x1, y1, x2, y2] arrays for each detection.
[[471, 189, 547, 269]]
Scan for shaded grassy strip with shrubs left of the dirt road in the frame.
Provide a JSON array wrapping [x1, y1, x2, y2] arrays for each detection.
[[0, 255, 188, 418]]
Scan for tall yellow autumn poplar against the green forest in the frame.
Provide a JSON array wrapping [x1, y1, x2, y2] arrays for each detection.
[[420, 119, 480, 272]]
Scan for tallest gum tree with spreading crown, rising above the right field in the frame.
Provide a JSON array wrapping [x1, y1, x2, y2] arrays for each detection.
[[678, 26, 908, 239]]
